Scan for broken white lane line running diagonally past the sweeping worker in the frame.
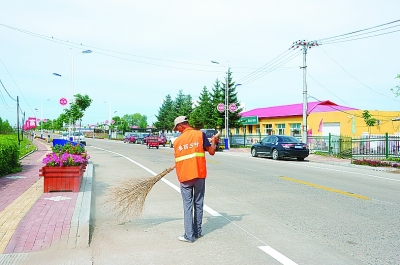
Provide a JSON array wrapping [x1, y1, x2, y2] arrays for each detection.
[[91, 146, 297, 265]]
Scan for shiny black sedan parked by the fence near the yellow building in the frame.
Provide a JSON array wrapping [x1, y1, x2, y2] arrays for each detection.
[[251, 135, 310, 161]]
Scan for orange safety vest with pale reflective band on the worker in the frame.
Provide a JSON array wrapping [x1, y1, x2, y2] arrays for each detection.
[[174, 128, 207, 182]]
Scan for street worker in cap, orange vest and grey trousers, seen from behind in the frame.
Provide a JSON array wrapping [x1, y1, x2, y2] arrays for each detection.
[[174, 116, 216, 243]]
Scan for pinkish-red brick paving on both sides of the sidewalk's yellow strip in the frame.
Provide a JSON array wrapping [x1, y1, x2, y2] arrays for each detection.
[[0, 139, 86, 254]]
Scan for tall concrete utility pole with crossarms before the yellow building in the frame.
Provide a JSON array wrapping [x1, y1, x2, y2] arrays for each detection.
[[291, 40, 318, 144]]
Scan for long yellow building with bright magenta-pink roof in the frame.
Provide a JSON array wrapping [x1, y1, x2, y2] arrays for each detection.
[[239, 100, 400, 138]]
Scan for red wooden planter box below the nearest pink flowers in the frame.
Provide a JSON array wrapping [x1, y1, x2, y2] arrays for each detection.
[[39, 165, 86, 193]]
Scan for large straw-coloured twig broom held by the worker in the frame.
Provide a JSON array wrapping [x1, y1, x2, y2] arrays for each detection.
[[107, 166, 175, 218]]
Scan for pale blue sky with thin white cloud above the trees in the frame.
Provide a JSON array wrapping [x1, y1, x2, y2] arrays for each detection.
[[0, 0, 400, 126]]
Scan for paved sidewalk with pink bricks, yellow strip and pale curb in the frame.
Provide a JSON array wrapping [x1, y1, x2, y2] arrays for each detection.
[[0, 139, 93, 264]]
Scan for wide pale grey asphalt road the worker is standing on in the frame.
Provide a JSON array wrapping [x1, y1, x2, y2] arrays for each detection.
[[87, 139, 400, 265]]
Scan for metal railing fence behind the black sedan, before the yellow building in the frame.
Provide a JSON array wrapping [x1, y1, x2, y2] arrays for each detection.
[[229, 133, 400, 159]]
